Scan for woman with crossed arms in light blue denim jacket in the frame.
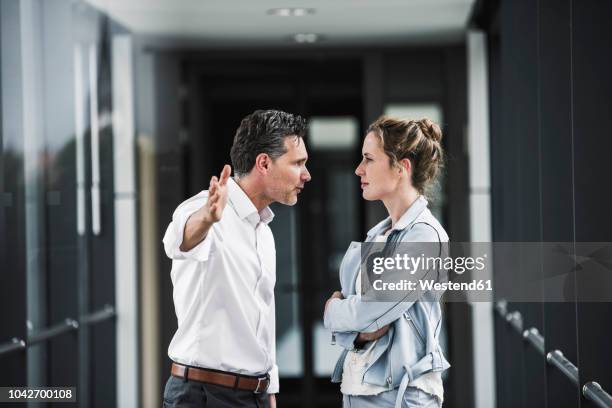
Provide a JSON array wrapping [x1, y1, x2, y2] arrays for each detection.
[[324, 116, 450, 408]]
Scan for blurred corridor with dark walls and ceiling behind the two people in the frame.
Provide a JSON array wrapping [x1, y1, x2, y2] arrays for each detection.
[[0, 0, 612, 408]]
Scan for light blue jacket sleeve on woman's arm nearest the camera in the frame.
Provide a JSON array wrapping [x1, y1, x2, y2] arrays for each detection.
[[323, 223, 439, 333]]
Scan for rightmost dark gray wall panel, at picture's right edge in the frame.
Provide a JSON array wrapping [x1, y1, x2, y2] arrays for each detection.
[[571, 0, 612, 407]]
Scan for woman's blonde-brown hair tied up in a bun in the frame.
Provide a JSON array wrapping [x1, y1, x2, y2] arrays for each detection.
[[367, 115, 444, 195]]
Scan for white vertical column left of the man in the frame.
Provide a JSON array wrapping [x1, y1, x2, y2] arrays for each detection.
[[112, 35, 140, 408]]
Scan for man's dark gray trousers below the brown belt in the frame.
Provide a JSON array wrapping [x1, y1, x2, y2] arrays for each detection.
[[163, 375, 269, 408]]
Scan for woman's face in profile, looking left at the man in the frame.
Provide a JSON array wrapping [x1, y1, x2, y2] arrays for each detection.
[[355, 132, 401, 201]]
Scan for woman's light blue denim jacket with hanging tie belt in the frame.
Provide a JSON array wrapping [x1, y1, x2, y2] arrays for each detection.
[[324, 197, 450, 402]]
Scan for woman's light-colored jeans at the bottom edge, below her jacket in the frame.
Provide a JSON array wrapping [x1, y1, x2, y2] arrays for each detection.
[[342, 386, 442, 408]]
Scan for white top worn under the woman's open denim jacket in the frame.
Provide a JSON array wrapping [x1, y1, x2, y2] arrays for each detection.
[[340, 234, 444, 404]]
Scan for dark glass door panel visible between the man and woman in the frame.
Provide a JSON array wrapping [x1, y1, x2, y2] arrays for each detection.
[[309, 117, 359, 378]]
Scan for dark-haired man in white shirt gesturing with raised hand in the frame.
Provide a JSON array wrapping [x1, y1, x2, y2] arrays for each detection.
[[163, 110, 310, 408]]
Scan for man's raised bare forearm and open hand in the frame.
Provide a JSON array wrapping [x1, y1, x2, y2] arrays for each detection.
[[180, 164, 232, 252]]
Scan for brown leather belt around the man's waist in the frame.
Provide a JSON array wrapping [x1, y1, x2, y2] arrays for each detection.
[[170, 363, 270, 394]]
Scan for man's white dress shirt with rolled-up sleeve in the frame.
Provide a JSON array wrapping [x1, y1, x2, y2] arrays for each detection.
[[163, 178, 279, 393]]
